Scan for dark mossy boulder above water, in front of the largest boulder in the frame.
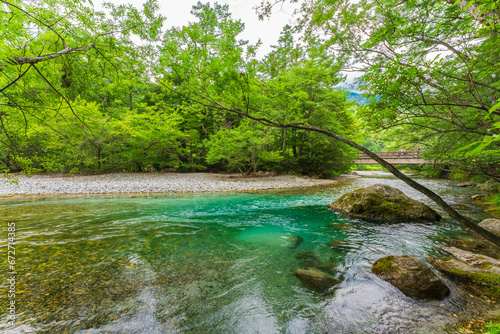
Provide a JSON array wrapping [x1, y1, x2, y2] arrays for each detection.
[[372, 255, 450, 299]]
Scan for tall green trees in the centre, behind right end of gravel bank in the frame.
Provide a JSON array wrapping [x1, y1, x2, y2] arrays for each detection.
[[155, 3, 354, 176]]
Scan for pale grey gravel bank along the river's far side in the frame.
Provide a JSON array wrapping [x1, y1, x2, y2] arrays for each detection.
[[0, 173, 337, 196]]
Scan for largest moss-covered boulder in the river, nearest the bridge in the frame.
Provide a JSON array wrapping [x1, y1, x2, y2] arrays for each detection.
[[330, 184, 441, 222]]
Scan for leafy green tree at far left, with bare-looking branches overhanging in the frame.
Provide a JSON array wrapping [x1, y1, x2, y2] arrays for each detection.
[[0, 0, 163, 174]]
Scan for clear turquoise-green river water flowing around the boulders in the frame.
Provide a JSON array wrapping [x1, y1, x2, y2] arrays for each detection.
[[0, 178, 492, 334]]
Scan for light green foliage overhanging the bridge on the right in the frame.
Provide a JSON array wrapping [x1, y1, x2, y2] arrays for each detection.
[[292, 0, 500, 180]]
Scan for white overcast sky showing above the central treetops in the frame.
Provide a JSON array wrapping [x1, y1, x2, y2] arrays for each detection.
[[94, 0, 295, 58]]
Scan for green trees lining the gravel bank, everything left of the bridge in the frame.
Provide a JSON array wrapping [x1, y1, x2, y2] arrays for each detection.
[[0, 0, 359, 176]]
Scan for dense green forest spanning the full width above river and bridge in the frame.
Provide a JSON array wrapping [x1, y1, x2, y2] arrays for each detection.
[[0, 0, 500, 182]]
